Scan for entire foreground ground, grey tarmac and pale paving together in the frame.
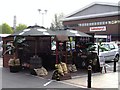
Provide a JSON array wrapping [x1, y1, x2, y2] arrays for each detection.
[[0, 57, 120, 90]]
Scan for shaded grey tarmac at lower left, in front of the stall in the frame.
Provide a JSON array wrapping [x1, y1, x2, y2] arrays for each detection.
[[2, 68, 80, 88]]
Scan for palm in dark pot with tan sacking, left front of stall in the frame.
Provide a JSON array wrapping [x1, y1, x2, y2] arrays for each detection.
[[3, 37, 28, 72]]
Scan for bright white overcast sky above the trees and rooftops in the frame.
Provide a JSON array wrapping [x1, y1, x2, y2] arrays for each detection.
[[0, 0, 120, 27]]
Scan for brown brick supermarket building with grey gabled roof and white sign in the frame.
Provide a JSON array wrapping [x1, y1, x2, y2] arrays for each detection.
[[63, 3, 120, 41]]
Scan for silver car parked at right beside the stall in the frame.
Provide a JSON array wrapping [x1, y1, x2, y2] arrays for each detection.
[[96, 42, 120, 61]]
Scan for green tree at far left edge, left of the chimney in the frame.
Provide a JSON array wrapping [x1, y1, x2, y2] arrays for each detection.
[[0, 23, 13, 34]]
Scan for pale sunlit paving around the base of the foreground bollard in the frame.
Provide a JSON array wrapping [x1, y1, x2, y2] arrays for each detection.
[[64, 72, 118, 88]]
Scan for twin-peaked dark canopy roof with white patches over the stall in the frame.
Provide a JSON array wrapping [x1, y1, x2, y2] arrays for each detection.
[[11, 25, 91, 37]]
